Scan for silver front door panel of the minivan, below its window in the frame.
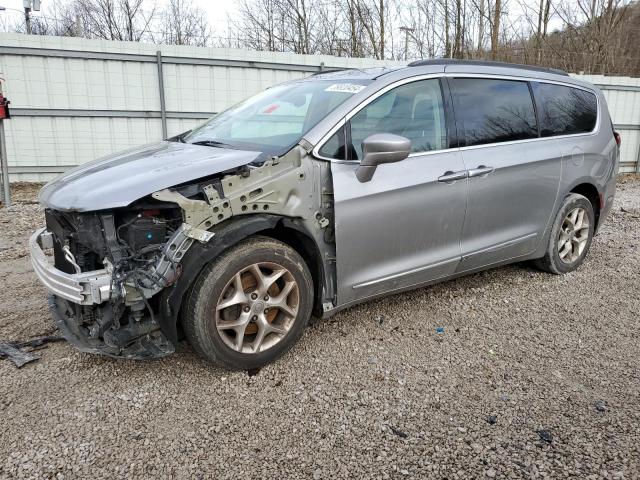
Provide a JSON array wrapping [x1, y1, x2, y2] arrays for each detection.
[[332, 151, 467, 303]]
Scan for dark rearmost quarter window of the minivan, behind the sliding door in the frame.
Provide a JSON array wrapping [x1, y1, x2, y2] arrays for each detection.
[[532, 82, 598, 137]]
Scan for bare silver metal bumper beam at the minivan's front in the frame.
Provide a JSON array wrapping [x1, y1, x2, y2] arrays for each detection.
[[29, 228, 112, 305]]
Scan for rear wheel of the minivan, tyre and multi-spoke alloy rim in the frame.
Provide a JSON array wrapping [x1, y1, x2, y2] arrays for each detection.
[[534, 193, 595, 275]]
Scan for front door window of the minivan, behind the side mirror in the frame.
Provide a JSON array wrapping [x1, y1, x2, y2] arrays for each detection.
[[349, 79, 447, 160]]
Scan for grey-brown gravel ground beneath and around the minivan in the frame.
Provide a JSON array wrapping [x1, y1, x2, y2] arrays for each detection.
[[0, 177, 640, 479]]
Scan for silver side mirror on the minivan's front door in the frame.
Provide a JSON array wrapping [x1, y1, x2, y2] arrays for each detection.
[[356, 133, 411, 183]]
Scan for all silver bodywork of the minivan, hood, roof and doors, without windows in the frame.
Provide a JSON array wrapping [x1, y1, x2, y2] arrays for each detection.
[[32, 64, 618, 334]]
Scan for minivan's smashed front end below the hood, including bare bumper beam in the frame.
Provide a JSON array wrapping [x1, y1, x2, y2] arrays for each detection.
[[30, 206, 185, 358]]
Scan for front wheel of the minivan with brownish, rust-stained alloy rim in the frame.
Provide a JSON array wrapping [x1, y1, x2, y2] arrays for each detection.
[[182, 236, 314, 370]]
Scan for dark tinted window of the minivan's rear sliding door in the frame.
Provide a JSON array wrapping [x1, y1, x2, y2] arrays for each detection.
[[451, 78, 538, 146]]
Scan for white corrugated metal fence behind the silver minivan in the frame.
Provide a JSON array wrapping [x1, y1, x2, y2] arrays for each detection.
[[0, 34, 640, 181]]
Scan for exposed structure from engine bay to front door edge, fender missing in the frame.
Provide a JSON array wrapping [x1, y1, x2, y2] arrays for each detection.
[[38, 146, 335, 358]]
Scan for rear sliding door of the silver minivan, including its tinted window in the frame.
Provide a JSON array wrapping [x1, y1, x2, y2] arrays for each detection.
[[449, 77, 563, 272]]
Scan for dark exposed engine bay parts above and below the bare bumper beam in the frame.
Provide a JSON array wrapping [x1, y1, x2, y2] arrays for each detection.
[[45, 206, 182, 357]]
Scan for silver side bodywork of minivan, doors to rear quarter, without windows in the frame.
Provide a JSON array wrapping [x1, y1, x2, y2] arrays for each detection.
[[305, 65, 619, 309]]
